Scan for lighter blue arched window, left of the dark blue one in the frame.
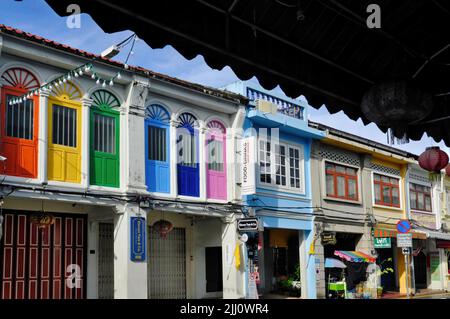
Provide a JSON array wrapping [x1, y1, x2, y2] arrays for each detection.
[[145, 104, 170, 193]]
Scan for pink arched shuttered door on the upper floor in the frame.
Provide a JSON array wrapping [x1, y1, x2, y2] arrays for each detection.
[[206, 121, 227, 200]]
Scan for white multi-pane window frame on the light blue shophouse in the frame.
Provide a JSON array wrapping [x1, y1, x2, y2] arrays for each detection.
[[256, 138, 306, 195]]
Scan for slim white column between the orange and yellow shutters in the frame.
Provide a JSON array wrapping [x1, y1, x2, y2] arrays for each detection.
[[38, 90, 50, 184]]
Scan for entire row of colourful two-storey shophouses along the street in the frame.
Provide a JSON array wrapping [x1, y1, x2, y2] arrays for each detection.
[[0, 26, 450, 299]]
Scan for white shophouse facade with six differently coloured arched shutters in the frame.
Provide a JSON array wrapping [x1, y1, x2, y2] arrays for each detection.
[[0, 26, 245, 299]]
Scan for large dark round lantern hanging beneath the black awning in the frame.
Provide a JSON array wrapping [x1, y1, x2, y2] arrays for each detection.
[[361, 81, 434, 138]]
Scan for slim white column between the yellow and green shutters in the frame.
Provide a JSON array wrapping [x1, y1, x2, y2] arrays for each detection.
[[80, 98, 93, 189]]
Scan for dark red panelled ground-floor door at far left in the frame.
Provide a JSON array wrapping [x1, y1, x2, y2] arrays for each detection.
[[0, 211, 86, 299]]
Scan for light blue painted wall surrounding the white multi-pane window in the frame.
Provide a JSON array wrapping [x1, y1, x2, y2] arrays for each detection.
[[225, 82, 325, 299]]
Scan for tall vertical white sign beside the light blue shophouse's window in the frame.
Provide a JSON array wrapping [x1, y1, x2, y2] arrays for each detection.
[[241, 136, 256, 195]]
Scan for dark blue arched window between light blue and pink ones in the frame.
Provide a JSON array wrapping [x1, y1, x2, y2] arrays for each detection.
[[177, 113, 200, 197]]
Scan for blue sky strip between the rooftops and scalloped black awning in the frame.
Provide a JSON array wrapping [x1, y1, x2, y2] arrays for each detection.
[[0, 0, 449, 154]]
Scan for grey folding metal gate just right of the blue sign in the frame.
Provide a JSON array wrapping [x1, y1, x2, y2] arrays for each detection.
[[148, 227, 186, 299]]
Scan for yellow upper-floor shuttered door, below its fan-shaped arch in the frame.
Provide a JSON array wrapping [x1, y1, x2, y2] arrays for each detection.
[[48, 97, 82, 183]]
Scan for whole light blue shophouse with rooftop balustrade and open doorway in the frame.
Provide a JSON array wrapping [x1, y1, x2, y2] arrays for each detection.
[[225, 82, 325, 298]]
